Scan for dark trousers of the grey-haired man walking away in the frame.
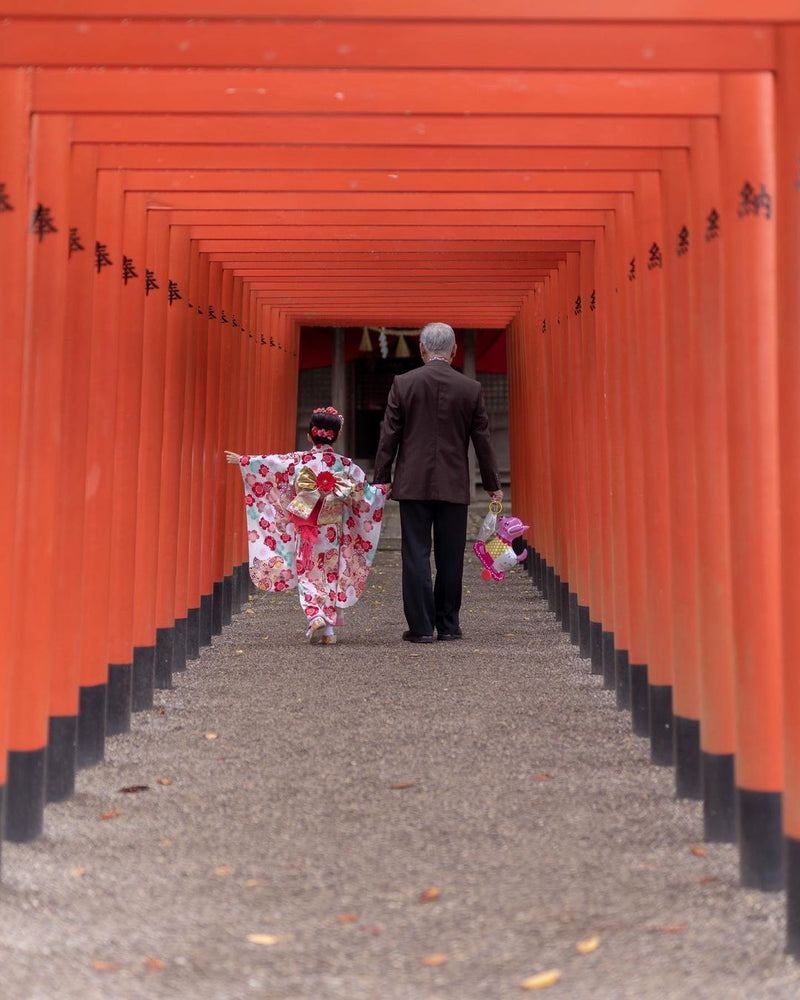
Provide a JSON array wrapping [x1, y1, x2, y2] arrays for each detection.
[[400, 500, 469, 635]]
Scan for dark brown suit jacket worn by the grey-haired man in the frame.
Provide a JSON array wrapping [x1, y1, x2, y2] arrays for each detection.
[[373, 361, 500, 503]]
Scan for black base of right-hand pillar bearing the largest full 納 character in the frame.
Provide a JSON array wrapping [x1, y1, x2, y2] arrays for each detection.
[[736, 788, 785, 892]]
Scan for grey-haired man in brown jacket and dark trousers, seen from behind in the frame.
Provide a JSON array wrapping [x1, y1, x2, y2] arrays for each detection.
[[373, 323, 503, 642]]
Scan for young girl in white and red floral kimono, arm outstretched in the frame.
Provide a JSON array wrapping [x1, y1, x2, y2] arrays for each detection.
[[225, 406, 389, 645]]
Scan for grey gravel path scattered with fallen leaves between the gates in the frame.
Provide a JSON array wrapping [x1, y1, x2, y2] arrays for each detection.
[[0, 505, 800, 1000]]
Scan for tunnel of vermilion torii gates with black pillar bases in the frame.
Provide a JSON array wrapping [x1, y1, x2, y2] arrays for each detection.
[[0, 0, 800, 954]]
